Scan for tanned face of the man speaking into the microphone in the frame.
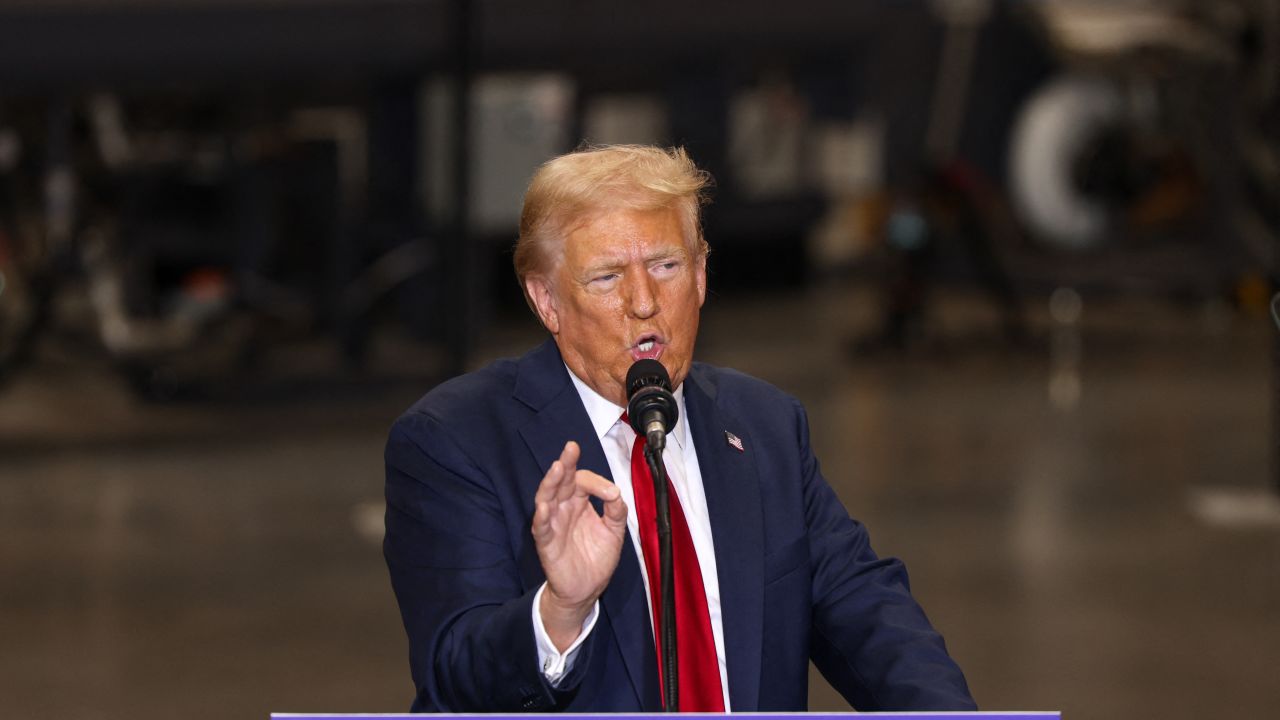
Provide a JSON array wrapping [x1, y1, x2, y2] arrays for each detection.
[[526, 209, 707, 406]]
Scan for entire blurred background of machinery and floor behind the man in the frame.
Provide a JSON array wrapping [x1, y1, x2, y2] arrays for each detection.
[[0, 0, 1280, 719]]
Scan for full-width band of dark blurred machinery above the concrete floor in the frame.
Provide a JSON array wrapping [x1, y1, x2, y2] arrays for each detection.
[[0, 0, 1280, 391]]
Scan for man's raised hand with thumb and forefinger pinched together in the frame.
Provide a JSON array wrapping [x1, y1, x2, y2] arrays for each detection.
[[532, 441, 627, 651]]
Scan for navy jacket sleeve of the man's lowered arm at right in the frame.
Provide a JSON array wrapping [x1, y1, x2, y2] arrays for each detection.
[[795, 402, 977, 711]]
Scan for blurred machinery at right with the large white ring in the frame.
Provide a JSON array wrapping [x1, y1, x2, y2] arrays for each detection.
[[855, 0, 1280, 350]]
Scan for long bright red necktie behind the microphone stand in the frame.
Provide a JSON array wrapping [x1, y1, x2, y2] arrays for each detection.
[[622, 414, 724, 712]]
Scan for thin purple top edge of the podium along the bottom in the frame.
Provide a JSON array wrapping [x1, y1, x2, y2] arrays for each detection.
[[271, 711, 1062, 720]]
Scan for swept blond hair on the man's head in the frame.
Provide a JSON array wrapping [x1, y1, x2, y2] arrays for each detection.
[[515, 145, 712, 301]]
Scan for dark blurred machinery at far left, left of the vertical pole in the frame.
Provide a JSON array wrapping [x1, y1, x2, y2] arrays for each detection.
[[0, 92, 433, 396]]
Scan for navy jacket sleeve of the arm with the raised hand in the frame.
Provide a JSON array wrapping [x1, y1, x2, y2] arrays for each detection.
[[383, 413, 593, 712]]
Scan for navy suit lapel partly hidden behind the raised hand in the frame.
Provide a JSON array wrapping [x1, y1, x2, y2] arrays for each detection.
[[513, 340, 662, 711]]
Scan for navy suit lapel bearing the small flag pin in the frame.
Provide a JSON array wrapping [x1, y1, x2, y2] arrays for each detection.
[[685, 366, 764, 712]]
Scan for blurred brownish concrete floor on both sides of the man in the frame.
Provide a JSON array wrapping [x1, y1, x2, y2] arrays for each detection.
[[0, 283, 1280, 720]]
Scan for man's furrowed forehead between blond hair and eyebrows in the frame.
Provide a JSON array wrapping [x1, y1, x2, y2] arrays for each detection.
[[564, 208, 687, 265]]
